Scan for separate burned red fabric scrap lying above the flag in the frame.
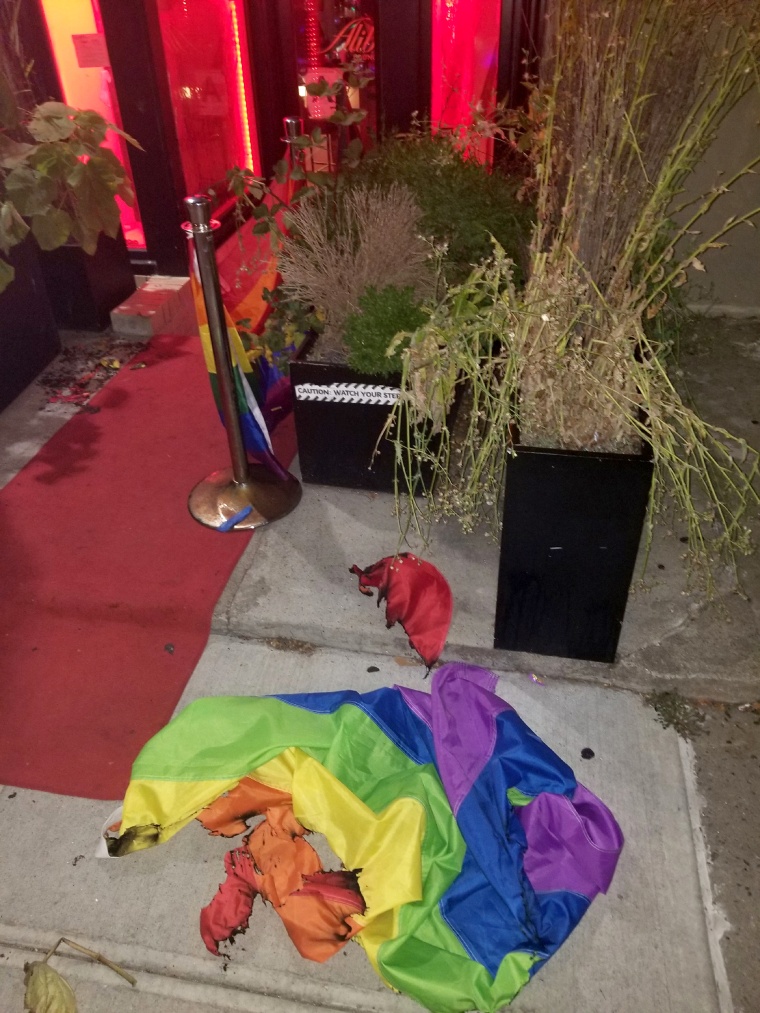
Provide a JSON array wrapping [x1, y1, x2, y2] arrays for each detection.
[[351, 552, 454, 669]]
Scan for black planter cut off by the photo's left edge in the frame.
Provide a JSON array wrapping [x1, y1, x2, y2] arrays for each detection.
[[0, 238, 61, 410]]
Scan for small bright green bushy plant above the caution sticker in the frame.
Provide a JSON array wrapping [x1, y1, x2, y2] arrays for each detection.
[[344, 285, 428, 376]]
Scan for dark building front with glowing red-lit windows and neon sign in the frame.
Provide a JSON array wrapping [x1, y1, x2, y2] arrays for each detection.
[[20, 0, 544, 275]]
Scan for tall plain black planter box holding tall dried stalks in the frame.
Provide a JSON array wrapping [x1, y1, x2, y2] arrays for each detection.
[[493, 447, 653, 663]]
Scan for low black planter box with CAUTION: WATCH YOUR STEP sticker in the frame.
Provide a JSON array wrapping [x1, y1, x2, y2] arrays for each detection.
[[290, 341, 401, 492]]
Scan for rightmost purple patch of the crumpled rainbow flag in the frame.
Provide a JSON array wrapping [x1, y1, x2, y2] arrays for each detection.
[[516, 784, 623, 901]]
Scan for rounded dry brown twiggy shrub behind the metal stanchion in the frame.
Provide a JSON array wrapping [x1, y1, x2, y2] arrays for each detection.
[[279, 184, 435, 359]]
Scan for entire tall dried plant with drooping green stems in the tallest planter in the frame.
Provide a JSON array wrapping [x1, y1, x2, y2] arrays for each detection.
[[393, 0, 760, 589]]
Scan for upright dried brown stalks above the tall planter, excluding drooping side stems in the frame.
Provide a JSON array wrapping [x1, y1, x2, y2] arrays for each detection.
[[522, 0, 760, 450]]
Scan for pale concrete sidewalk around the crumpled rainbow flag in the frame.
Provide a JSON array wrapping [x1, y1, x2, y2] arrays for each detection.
[[0, 644, 723, 1013]]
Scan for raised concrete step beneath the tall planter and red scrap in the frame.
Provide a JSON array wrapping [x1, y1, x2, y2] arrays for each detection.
[[213, 469, 760, 701]]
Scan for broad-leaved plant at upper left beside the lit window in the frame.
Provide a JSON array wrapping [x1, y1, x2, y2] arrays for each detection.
[[0, 72, 139, 292]]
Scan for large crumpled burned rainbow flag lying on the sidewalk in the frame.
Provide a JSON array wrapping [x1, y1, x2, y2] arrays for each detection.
[[109, 664, 622, 1013]]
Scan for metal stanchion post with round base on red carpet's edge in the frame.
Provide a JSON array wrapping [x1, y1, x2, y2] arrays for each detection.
[[182, 194, 301, 531]]
